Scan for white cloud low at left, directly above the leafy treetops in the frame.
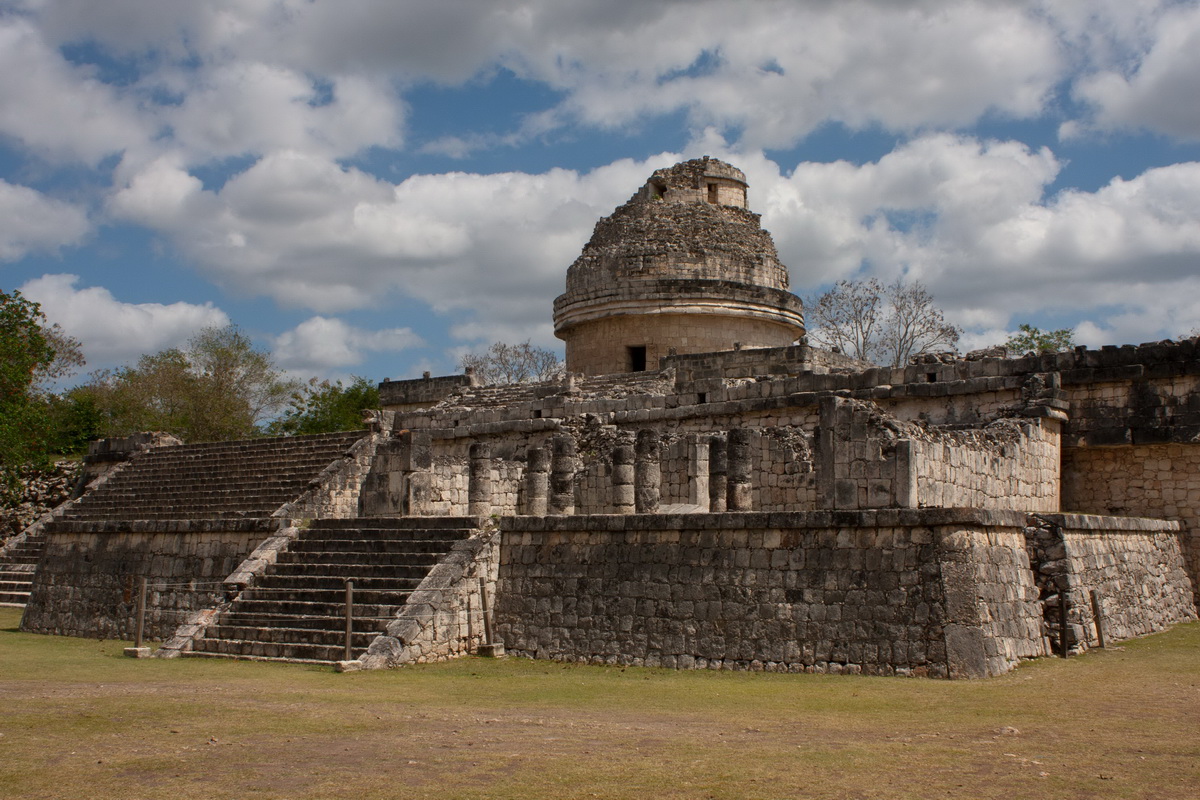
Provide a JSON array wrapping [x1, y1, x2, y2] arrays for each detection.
[[20, 275, 229, 368]]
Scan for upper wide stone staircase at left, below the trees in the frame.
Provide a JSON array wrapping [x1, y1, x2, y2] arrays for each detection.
[[52, 431, 367, 524]]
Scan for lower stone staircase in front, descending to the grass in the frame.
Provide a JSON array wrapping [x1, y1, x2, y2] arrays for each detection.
[[184, 517, 478, 663]]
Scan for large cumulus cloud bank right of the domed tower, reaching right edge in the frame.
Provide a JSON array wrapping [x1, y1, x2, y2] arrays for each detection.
[[757, 134, 1200, 343]]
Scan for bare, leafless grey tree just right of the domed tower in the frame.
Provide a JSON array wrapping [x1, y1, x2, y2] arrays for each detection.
[[805, 278, 961, 367]]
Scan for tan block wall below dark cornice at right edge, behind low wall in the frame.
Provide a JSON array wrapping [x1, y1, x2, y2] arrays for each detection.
[[1062, 443, 1200, 594]]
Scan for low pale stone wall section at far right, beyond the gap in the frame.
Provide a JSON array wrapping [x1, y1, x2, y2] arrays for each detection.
[[1026, 515, 1196, 649]]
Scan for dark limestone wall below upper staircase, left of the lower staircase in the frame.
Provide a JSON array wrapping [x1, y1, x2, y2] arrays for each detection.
[[22, 519, 276, 639]]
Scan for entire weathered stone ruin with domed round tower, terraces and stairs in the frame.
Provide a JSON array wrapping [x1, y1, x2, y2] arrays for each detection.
[[11, 160, 1200, 678]]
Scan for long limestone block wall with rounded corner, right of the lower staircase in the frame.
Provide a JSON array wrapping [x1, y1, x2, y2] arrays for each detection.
[[496, 511, 1044, 678]]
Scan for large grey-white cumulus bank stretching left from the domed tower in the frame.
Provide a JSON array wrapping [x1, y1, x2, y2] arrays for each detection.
[[109, 152, 674, 338]]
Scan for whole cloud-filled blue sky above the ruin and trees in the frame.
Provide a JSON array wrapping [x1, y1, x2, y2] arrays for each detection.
[[0, 0, 1200, 388]]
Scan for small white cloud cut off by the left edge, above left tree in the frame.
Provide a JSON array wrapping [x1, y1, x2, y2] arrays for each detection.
[[0, 180, 89, 261]]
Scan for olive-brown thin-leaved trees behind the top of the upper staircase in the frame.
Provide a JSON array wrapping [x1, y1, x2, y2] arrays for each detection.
[[78, 325, 298, 441]]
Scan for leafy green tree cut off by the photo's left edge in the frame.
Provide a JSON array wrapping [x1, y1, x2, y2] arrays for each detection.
[[0, 291, 83, 488]]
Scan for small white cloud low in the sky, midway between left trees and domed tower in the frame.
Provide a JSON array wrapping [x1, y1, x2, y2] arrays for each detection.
[[275, 317, 424, 373]]
